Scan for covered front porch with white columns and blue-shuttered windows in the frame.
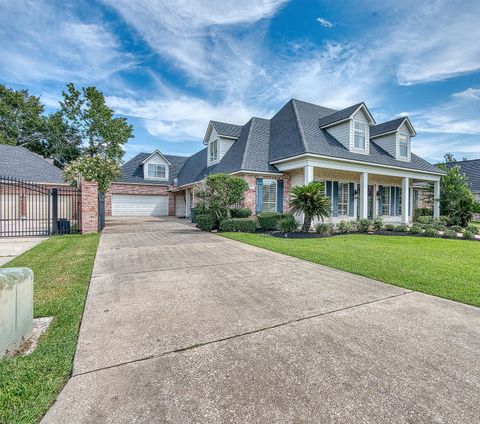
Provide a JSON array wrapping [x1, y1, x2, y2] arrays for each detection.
[[276, 158, 440, 224]]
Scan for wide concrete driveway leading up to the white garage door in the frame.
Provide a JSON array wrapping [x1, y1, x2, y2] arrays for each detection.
[[44, 218, 480, 423]]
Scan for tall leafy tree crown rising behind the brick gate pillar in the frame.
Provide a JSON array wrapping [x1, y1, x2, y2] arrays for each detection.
[[60, 83, 133, 161]]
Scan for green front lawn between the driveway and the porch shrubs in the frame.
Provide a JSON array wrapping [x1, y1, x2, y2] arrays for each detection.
[[221, 233, 480, 306]]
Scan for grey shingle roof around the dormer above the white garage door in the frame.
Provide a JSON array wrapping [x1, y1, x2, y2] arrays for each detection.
[[115, 153, 188, 185]]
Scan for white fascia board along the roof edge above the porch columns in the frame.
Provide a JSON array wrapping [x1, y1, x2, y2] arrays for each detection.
[[272, 155, 443, 181]]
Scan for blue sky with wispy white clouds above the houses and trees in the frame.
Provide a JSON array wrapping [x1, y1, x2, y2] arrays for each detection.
[[0, 0, 480, 161]]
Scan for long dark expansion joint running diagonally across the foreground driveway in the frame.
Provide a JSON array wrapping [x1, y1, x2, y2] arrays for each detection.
[[71, 290, 417, 378]]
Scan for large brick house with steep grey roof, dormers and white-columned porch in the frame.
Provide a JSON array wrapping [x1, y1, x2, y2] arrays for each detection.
[[111, 99, 443, 223]]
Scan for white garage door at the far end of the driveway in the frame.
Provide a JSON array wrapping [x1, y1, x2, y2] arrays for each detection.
[[112, 194, 168, 216]]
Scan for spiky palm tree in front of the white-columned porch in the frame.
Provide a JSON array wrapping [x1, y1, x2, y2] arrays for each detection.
[[290, 181, 331, 232]]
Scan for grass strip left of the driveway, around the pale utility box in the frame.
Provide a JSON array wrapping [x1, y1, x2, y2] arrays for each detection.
[[0, 235, 99, 423]]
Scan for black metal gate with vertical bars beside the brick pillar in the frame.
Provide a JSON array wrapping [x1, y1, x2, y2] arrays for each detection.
[[0, 177, 81, 237]]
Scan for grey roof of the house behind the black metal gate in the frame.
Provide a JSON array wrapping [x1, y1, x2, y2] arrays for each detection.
[[0, 144, 64, 184]]
